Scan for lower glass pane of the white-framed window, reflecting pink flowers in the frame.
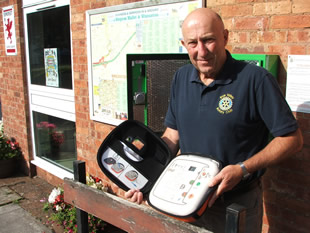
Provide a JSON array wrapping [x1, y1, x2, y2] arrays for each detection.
[[33, 112, 76, 171]]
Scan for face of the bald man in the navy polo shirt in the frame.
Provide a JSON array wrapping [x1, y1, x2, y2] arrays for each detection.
[[182, 18, 228, 78]]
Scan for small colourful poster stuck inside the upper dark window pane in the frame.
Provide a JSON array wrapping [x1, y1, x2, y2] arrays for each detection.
[[44, 48, 59, 87]]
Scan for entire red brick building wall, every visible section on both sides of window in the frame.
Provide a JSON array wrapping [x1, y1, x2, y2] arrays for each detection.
[[0, 0, 310, 233]]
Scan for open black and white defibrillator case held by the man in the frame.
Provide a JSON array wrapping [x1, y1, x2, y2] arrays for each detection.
[[97, 120, 222, 222]]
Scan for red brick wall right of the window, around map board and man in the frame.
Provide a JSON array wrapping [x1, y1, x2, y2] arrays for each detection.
[[71, 0, 310, 233]]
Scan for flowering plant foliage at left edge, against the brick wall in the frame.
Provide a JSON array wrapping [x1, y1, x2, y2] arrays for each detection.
[[0, 122, 22, 160]]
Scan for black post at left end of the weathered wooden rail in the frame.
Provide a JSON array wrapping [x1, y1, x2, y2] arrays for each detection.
[[73, 160, 88, 233]]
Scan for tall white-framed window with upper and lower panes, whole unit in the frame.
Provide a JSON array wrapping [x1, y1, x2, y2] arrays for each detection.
[[23, 0, 77, 178]]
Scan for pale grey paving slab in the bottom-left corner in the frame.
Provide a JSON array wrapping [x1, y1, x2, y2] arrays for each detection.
[[0, 203, 52, 233]]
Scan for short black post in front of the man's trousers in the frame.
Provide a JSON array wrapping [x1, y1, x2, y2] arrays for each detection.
[[225, 203, 246, 233]]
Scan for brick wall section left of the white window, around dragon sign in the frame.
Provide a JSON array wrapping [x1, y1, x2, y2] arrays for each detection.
[[0, 0, 31, 173]]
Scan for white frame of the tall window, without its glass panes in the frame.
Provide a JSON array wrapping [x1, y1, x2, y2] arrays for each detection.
[[23, 0, 75, 179]]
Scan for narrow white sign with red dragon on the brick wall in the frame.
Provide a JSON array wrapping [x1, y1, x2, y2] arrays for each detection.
[[2, 6, 17, 55]]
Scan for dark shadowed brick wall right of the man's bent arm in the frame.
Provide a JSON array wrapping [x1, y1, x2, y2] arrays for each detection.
[[262, 101, 310, 233]]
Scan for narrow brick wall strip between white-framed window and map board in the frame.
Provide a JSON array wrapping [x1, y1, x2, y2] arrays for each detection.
[[71, 0, 142, 195]]
